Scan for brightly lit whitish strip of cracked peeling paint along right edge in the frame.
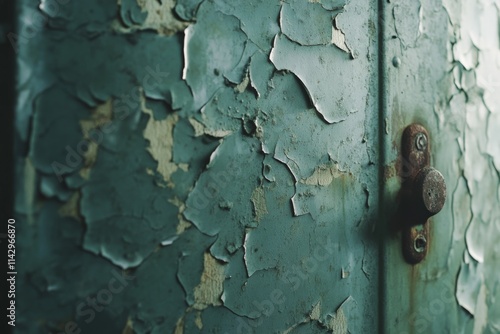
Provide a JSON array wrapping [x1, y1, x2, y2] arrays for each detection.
[[451, 1, 500, 333]]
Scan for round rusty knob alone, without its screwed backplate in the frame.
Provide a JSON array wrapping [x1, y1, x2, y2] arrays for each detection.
[[413, 167, 446, 222]]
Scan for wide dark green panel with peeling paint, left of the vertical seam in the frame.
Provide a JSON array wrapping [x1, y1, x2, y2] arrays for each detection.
[[16, 0, 378, 334]]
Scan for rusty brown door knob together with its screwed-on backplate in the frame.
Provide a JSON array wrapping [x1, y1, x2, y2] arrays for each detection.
[[397, 124, 446, 264]]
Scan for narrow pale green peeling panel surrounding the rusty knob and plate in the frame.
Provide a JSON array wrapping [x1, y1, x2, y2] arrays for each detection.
[[383, 0, 500, 333]]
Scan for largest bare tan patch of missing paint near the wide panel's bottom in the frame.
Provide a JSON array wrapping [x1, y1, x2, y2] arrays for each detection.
[[193, 253, 225, 310]]
